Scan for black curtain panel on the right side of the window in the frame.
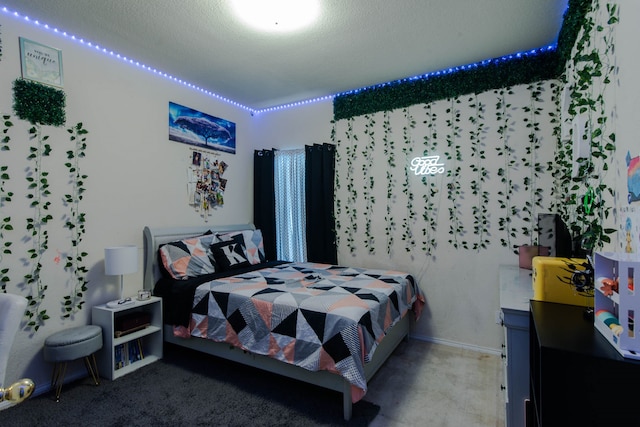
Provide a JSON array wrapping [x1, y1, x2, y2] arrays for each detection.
[[305, 144, 338, 264]]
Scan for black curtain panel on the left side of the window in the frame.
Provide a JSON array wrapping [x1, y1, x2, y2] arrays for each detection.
[[253, 150, 277, 261]]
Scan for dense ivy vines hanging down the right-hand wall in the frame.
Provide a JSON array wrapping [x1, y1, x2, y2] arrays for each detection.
[[558, 1, 619, 250]]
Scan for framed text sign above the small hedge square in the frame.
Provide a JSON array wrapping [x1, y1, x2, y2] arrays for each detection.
[[19, 37, 63, 87]]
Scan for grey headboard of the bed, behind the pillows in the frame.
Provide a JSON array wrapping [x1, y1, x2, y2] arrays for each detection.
[[142, 224, 255, 291]]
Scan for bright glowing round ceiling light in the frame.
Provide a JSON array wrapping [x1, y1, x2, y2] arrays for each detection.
[[231, 0, 320, 32]]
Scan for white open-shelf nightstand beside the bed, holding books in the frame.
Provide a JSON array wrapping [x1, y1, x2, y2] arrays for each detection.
[[91, 297, 162, 380]]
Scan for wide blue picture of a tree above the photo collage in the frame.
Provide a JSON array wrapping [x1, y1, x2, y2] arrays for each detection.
[[169, 102, 236, 154]]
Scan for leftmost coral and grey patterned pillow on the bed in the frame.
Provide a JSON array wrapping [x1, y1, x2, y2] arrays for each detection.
[[158, 234, 216, 280]]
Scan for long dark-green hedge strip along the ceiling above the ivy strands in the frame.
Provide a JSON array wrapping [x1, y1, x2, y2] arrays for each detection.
[[333, 0, 592, 120]]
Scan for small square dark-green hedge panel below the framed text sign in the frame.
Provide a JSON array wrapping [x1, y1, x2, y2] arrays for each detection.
[[13, 79, 66, 127]]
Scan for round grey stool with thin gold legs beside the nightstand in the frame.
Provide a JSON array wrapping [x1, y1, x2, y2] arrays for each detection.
[[44, 325, 102, 402]]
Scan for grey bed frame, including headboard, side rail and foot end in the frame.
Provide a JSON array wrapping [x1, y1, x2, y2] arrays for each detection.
[[143, 224, 411, 421]]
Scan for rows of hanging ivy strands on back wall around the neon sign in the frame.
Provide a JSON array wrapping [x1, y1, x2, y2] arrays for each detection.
[[333, 81, 558, 257]]
